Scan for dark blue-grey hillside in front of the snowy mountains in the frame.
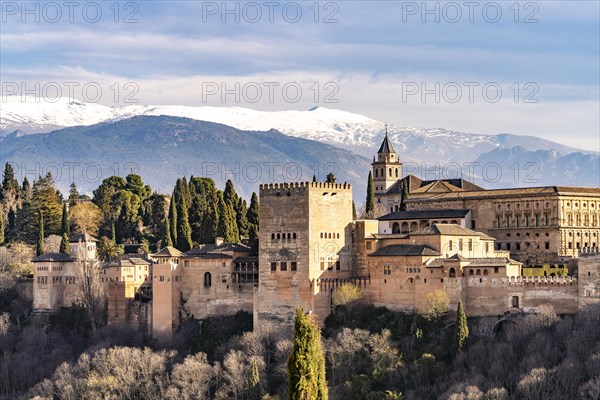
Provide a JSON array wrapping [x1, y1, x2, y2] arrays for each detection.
[[0, 116, 370, 198]]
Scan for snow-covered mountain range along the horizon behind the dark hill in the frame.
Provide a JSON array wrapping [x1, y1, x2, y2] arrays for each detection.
[[0, 96, 600, 187]]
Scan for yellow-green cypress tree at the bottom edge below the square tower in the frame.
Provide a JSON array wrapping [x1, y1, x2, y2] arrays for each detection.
[[287, 308, 328, 400]]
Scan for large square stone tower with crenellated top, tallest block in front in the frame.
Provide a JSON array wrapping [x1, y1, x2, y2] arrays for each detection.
[[254, 182, 353, 329]]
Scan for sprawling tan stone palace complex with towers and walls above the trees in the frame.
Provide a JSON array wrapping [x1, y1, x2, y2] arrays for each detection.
[[34, 134, 600, 340]]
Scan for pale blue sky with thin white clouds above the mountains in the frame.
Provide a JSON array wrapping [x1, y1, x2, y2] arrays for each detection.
[[0, 1, 600, 151]]
